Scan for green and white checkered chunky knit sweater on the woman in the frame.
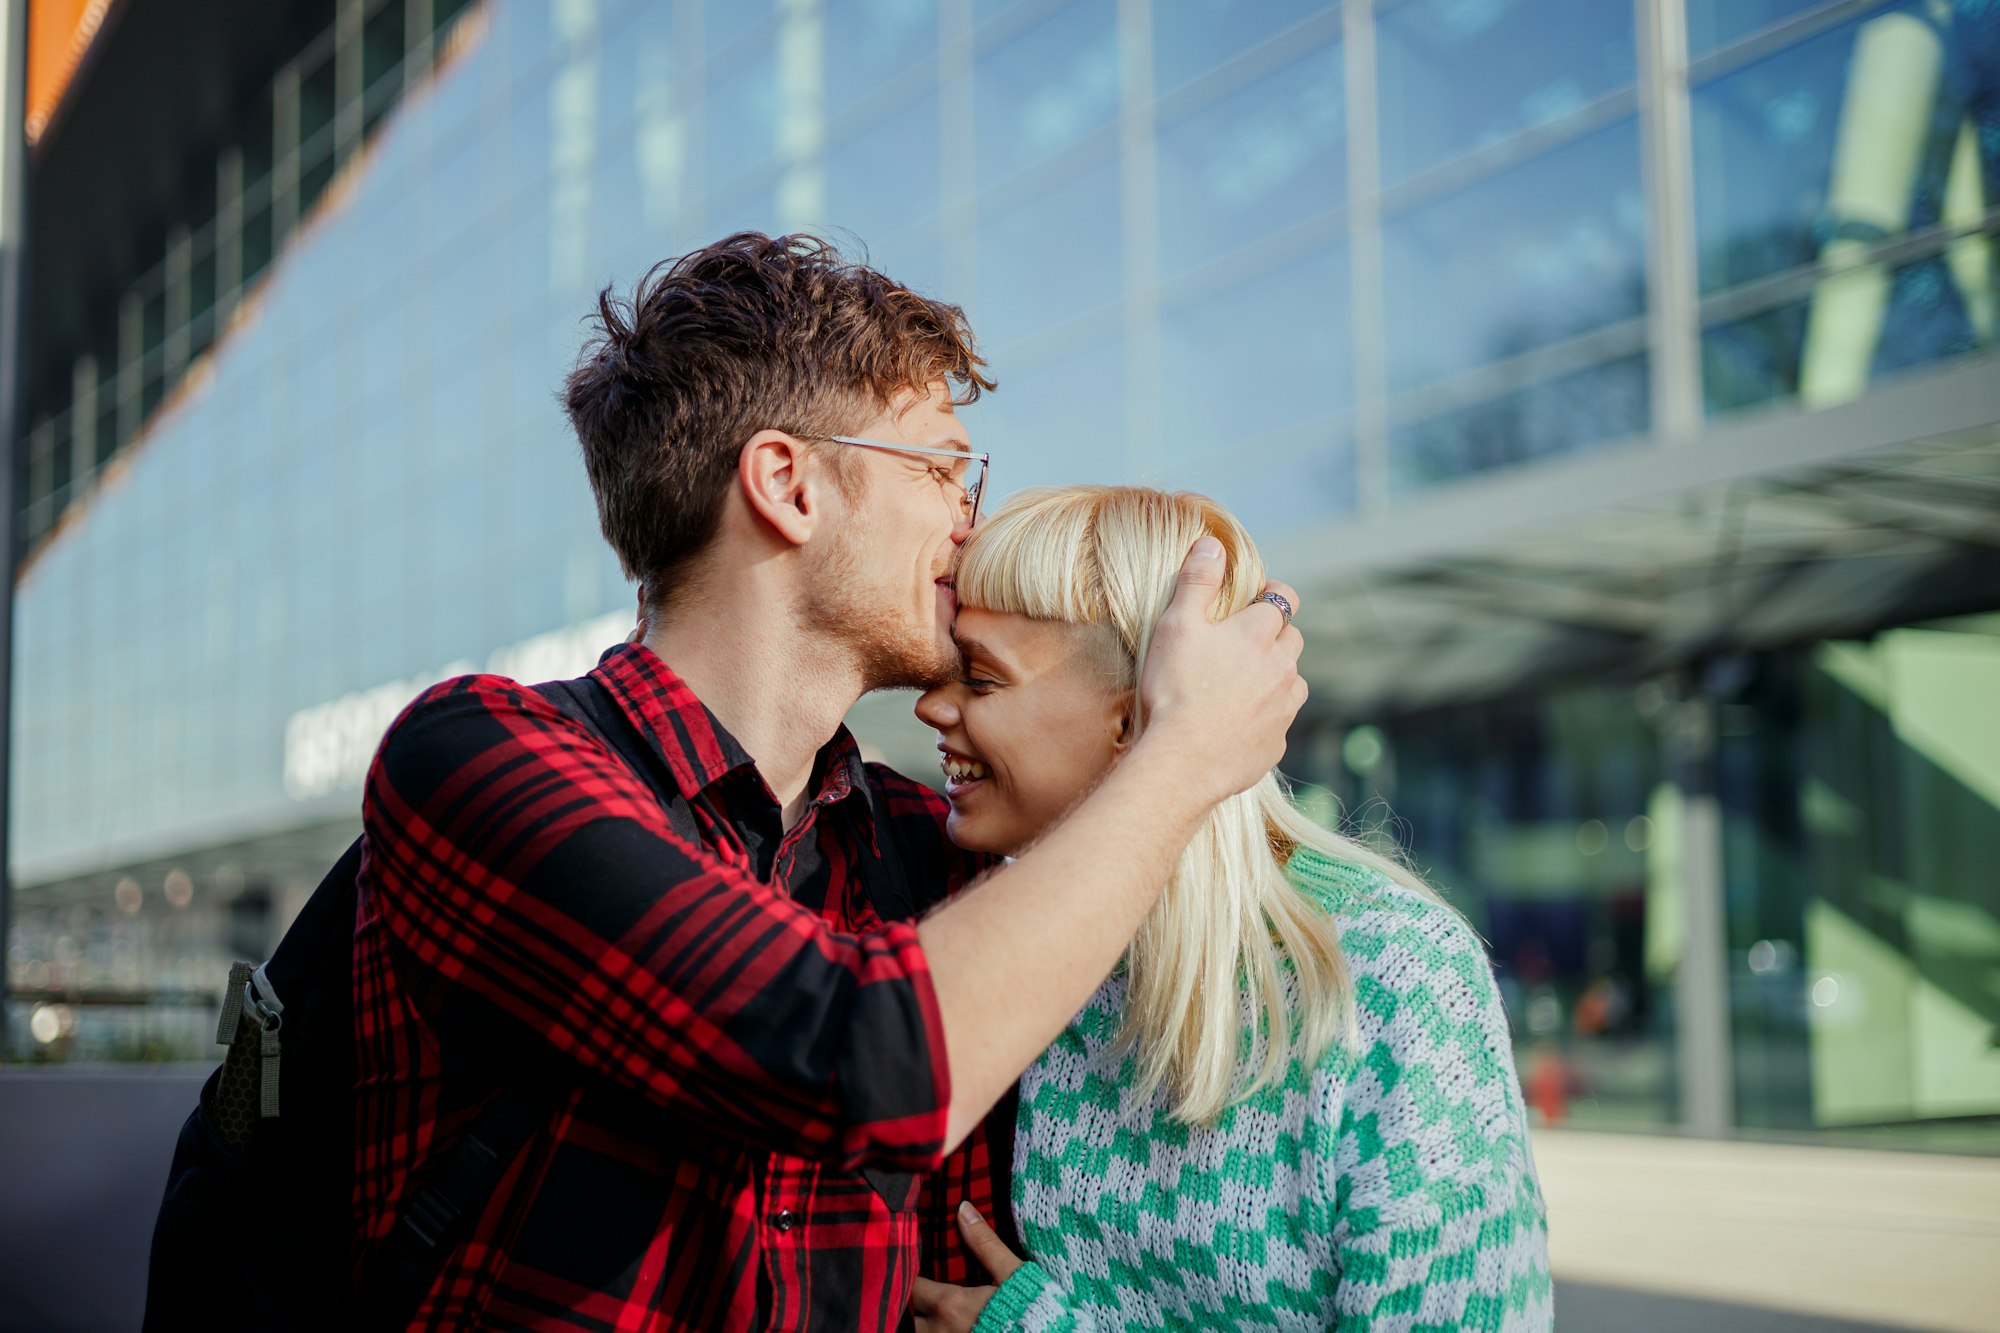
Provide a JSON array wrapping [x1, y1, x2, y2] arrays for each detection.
[[978, 851, 1552, 1333]]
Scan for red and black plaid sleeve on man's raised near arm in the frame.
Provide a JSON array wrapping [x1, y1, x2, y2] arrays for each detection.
[[362, 677, 950, 1171]]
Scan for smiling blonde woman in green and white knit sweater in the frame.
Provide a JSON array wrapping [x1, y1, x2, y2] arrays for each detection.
[[916, 486, 1550, 1333]]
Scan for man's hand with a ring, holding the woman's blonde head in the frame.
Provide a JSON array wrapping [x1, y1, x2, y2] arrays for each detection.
[[1138, 536, 1306, 801]]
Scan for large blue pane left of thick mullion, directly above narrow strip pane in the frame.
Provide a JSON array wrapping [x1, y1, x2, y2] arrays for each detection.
[[1382, 120, 1646, 388]]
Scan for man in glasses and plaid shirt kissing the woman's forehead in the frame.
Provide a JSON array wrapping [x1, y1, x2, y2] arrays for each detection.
[[356, 234, 1304, 1331]]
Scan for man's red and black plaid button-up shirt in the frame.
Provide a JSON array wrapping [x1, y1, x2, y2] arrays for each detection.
[[354, 646, 1012, 1333]]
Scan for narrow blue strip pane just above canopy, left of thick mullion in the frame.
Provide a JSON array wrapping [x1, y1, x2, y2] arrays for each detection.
[[1390, 356, 1652, 490]]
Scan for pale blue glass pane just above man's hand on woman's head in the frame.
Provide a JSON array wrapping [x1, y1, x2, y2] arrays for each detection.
[[1160, 246, 1354, 466]]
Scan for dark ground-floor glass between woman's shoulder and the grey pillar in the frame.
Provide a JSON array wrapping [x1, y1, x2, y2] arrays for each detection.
[[1300, 685, 1680, 1129]]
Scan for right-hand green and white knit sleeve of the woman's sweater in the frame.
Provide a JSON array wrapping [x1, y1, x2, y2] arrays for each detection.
[[1330, 903, 1554, 1333]]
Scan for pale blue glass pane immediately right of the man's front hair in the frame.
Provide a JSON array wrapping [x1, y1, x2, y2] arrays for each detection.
[[974, 160, 1124, 350]]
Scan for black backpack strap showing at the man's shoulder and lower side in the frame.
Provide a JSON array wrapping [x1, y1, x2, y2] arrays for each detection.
[[356, 677, 700, 1331]]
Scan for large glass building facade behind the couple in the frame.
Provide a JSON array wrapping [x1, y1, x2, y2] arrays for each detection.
[[8, 0, 2000, 1151]]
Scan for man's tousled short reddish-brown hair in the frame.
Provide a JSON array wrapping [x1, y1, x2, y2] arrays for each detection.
[[564, 232, 994, 610]]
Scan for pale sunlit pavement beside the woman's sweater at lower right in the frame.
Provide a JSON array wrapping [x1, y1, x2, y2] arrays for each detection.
[[1534, 1131, 2000, 1333]]
